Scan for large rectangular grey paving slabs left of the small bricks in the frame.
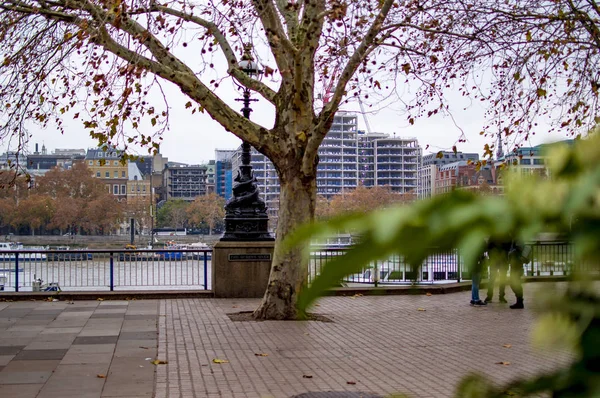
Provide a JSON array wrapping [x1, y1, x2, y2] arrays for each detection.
[[0, 300, 158, 398]]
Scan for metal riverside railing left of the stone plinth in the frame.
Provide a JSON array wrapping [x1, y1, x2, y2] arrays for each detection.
[[0, 248, 212, 292]]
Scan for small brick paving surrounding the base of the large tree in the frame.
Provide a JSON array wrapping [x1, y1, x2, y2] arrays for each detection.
[[156, 284, 571, 398]]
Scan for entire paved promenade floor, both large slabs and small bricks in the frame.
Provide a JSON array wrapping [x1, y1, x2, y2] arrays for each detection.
[[0, 283, 572, 398]]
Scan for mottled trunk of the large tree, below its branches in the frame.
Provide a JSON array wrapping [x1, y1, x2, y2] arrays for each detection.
[[254, 169, 316, 319]]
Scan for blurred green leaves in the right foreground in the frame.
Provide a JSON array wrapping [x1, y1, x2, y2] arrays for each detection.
[[288, 136, 600, 397]]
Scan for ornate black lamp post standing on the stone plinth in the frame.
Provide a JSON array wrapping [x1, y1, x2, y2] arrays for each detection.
[[221, 47, 274, 241]]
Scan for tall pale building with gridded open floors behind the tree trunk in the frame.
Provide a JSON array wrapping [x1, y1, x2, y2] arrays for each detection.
[[232, 111, 421, 225]]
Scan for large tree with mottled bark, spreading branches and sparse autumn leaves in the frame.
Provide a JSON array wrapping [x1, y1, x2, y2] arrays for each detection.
[[0, 0, 599, 319]]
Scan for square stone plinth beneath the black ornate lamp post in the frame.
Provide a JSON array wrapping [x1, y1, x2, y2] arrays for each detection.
[[212, 241, 275, 298]]
